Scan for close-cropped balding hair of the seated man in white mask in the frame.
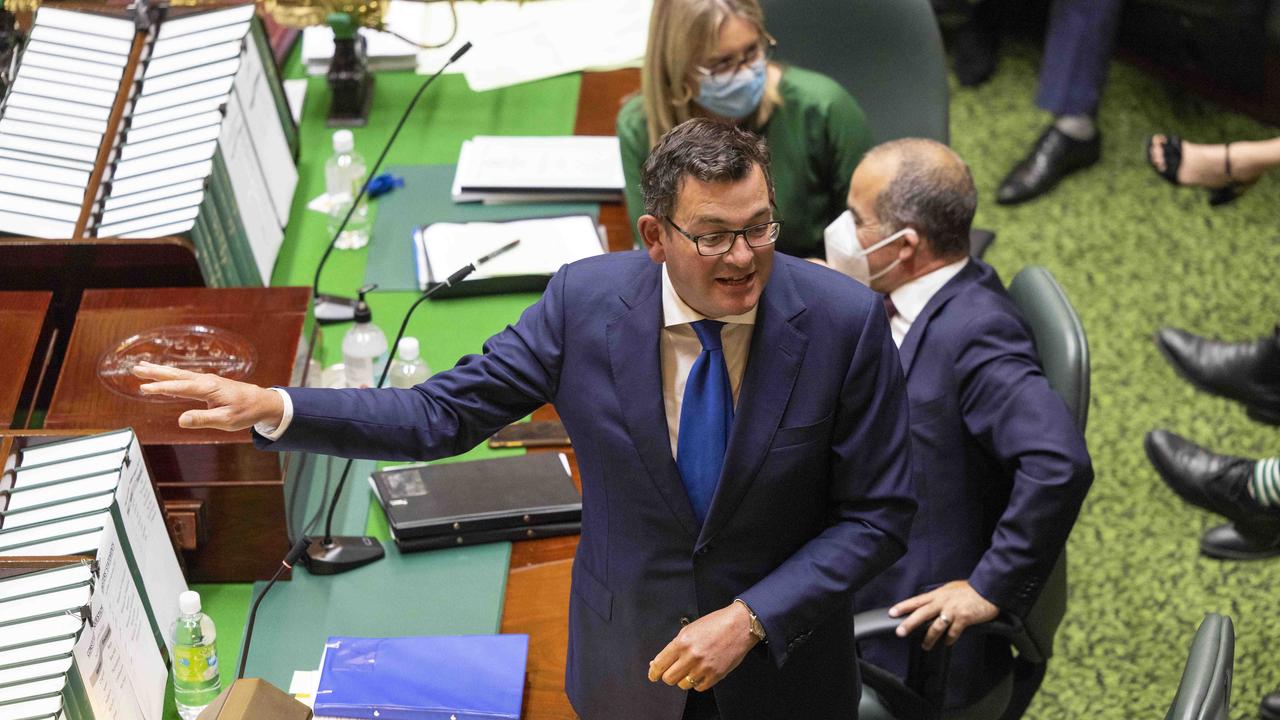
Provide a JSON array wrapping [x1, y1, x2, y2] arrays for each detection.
[[867, 138, 978, 258]]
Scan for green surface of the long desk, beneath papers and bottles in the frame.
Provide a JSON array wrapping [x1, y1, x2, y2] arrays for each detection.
[[165, 49, 581, 720]]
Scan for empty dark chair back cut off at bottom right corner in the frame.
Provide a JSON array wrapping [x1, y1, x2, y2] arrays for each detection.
[[1165, 612, 1235, 720]]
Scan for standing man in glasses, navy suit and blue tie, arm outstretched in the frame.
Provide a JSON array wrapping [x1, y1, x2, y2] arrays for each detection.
[[136, 120, 915, 720]]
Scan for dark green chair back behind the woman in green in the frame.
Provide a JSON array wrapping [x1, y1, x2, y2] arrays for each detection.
[[760, 0, 996, 258]]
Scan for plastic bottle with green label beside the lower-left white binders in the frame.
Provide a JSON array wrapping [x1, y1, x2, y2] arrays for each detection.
[[173, 591, 223, 720]]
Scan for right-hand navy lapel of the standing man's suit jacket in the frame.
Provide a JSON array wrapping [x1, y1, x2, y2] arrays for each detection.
[[698, 259, 809, 547]]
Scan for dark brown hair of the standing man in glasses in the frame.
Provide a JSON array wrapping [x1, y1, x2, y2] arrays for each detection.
[[640, 118, 773, 218]]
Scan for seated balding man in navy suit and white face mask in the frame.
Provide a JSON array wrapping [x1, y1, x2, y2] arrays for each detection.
[[827, 140, 1093, 705]]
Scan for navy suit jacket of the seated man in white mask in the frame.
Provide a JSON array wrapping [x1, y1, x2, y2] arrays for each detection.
[[856, 259, 1093, 705]]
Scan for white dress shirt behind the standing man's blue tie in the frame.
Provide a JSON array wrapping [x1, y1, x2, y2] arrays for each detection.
[[659, 263, 759, 457]]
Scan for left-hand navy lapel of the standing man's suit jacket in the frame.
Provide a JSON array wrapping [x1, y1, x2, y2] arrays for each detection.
[[605, 265, 698, 537]]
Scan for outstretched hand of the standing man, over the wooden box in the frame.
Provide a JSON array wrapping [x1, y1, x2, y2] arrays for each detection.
[[132, 361, 284, 432]]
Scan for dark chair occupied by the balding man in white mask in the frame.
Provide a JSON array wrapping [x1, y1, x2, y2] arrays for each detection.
[[854, 265, 1089, 720]]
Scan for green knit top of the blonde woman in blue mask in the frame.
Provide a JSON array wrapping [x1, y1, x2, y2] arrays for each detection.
[[617, 67, 872, 258]]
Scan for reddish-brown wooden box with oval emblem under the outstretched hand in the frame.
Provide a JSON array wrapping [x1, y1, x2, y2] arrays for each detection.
[[45, 287, 310, 582]]
